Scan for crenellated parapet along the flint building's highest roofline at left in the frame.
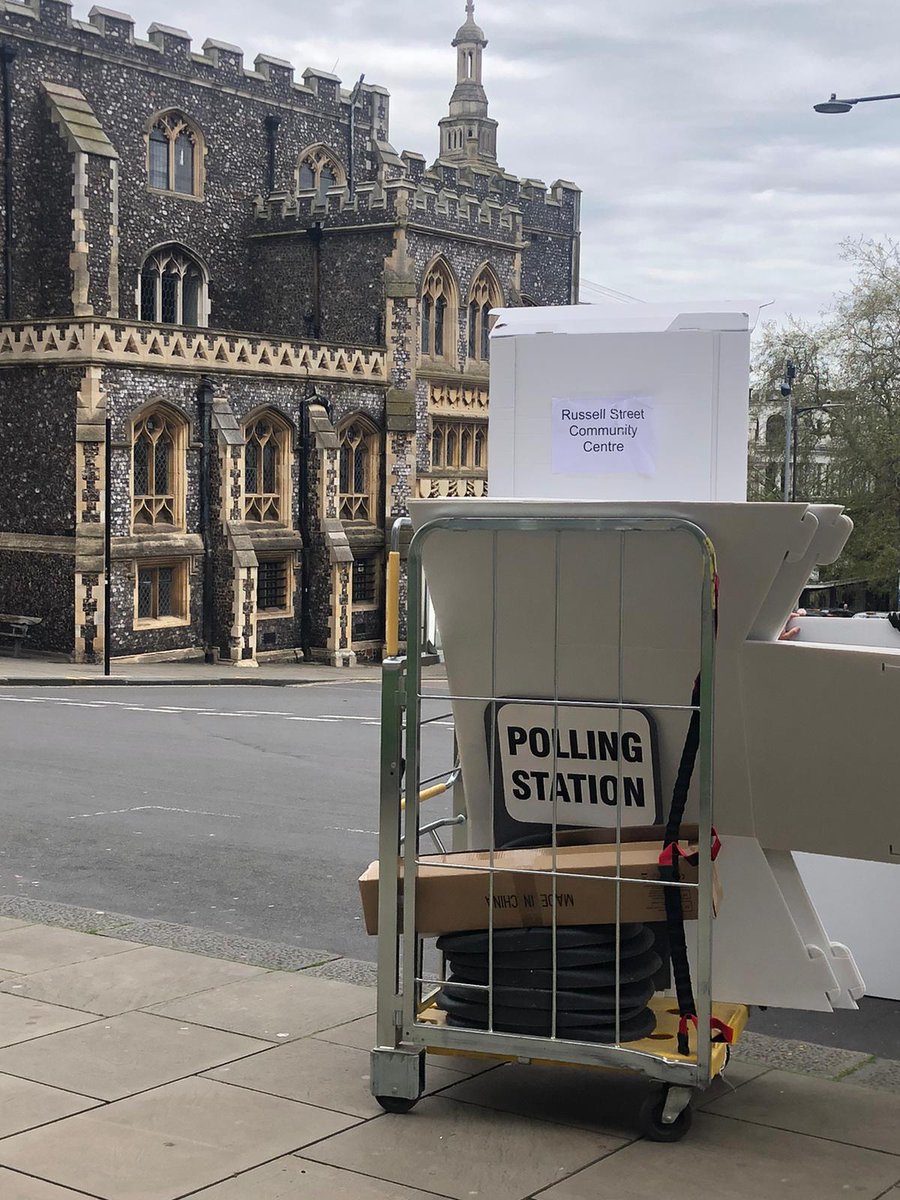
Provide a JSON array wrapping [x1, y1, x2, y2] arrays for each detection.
[[0, 0, 390, 132]]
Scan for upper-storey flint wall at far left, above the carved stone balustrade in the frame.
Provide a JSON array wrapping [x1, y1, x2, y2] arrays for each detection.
[[2, 0, 386, 328]]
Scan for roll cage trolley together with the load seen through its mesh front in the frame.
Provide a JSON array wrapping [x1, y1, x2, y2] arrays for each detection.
[[372, 516, 746, 1140]]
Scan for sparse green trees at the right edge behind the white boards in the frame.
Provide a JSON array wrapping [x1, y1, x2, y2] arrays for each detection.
[[750, 241, 900, 598]]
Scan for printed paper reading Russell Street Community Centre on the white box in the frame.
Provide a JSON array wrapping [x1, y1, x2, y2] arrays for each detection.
[[551, 397, 656, 475]]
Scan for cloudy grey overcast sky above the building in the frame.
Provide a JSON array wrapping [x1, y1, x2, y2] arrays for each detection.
[[76, 0, 900, 326]]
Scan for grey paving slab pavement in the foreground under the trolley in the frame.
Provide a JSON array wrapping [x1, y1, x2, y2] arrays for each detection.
[[0, 899, 900, 1200]]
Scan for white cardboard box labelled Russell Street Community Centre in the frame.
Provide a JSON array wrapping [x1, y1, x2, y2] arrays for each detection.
[[488, 305, 752, 500]]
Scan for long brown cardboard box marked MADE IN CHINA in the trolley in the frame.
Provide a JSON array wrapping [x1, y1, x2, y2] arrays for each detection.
[[359, 841, 720, 936]]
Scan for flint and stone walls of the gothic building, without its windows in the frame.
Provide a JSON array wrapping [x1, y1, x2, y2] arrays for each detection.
[[0, 0, 580, 660]]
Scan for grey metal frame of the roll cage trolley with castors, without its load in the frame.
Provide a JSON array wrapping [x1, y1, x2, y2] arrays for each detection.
[[371, 516, 746, 1141]]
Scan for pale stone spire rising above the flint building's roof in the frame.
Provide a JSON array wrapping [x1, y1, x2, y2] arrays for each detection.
[[440, 0, 497, 167]]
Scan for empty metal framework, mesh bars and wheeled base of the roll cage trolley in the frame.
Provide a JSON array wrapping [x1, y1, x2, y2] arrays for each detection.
[[371, 516, 748, 1141]]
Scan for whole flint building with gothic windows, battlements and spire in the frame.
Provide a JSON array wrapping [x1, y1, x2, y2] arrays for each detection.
[[0, 0, 580, 665]]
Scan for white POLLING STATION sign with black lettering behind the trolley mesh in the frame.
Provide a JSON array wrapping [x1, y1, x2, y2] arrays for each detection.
[[494, 701, 662, 829]]
